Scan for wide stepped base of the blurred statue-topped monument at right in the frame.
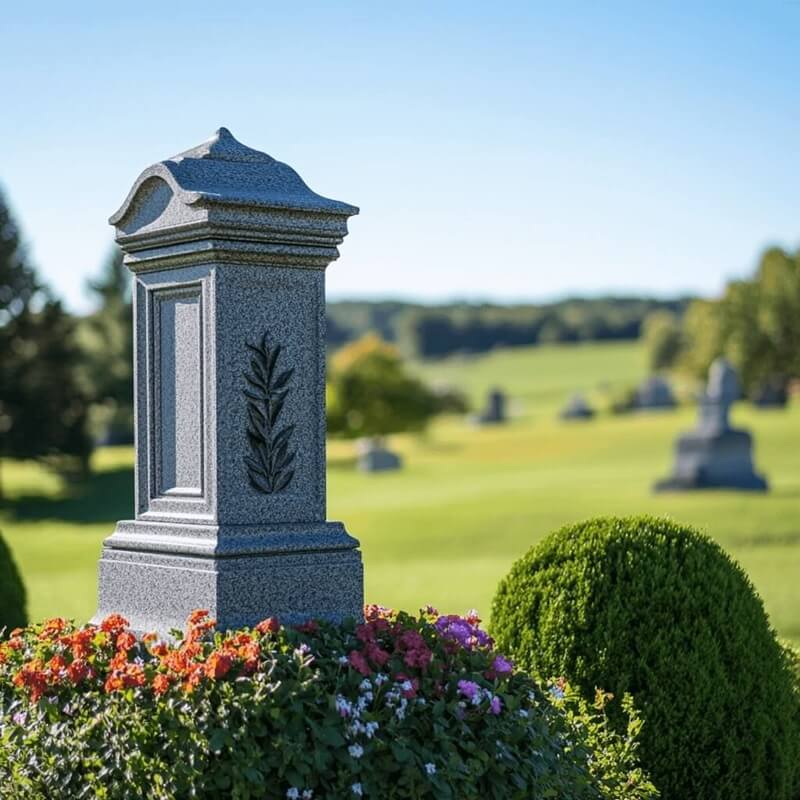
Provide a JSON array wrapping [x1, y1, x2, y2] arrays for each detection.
[[654, 428, 767, 492]]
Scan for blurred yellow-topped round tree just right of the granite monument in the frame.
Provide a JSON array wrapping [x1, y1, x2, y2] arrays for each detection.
[[328, 334, 439, 438]]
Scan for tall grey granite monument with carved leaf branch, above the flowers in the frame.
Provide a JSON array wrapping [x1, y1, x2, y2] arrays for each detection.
[[97, 128, 363, 633]]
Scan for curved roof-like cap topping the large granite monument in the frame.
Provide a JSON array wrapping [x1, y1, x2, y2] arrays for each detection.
[[109, 128, 358, 226]]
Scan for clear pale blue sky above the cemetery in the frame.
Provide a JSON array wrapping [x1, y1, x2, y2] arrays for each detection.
[[0, 0, 800, 309]]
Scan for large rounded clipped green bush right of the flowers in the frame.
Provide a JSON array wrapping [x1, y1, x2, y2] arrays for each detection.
[[491, 517, 800, 800]]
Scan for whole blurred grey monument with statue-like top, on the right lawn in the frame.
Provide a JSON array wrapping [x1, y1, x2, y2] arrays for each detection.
[[655, 359, 767, 491]]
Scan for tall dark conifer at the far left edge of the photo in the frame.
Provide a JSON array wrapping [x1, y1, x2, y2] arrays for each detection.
[[0, 189, 91, 493]]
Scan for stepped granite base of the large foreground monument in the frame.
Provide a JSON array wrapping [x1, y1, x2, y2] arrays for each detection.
[[92, 521, 364, 635]]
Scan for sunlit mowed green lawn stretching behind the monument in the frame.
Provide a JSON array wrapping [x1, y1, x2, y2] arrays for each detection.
[[0, 344, 800, 641]]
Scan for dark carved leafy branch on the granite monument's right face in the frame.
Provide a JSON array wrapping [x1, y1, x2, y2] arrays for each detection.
[[242, 333, 295, 494]]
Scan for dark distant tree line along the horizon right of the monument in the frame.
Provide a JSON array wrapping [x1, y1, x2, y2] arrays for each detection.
[[328, 297, 690, 358]]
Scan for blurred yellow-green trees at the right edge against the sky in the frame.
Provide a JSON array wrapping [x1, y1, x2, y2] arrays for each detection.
[[643, 247, 800, 398]]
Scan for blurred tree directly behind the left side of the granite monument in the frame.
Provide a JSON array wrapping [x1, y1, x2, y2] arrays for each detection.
[[78, 245, 133, 444]]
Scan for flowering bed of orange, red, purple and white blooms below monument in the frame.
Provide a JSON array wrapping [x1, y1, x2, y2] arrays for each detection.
[[0, 606, 655, 800]]
